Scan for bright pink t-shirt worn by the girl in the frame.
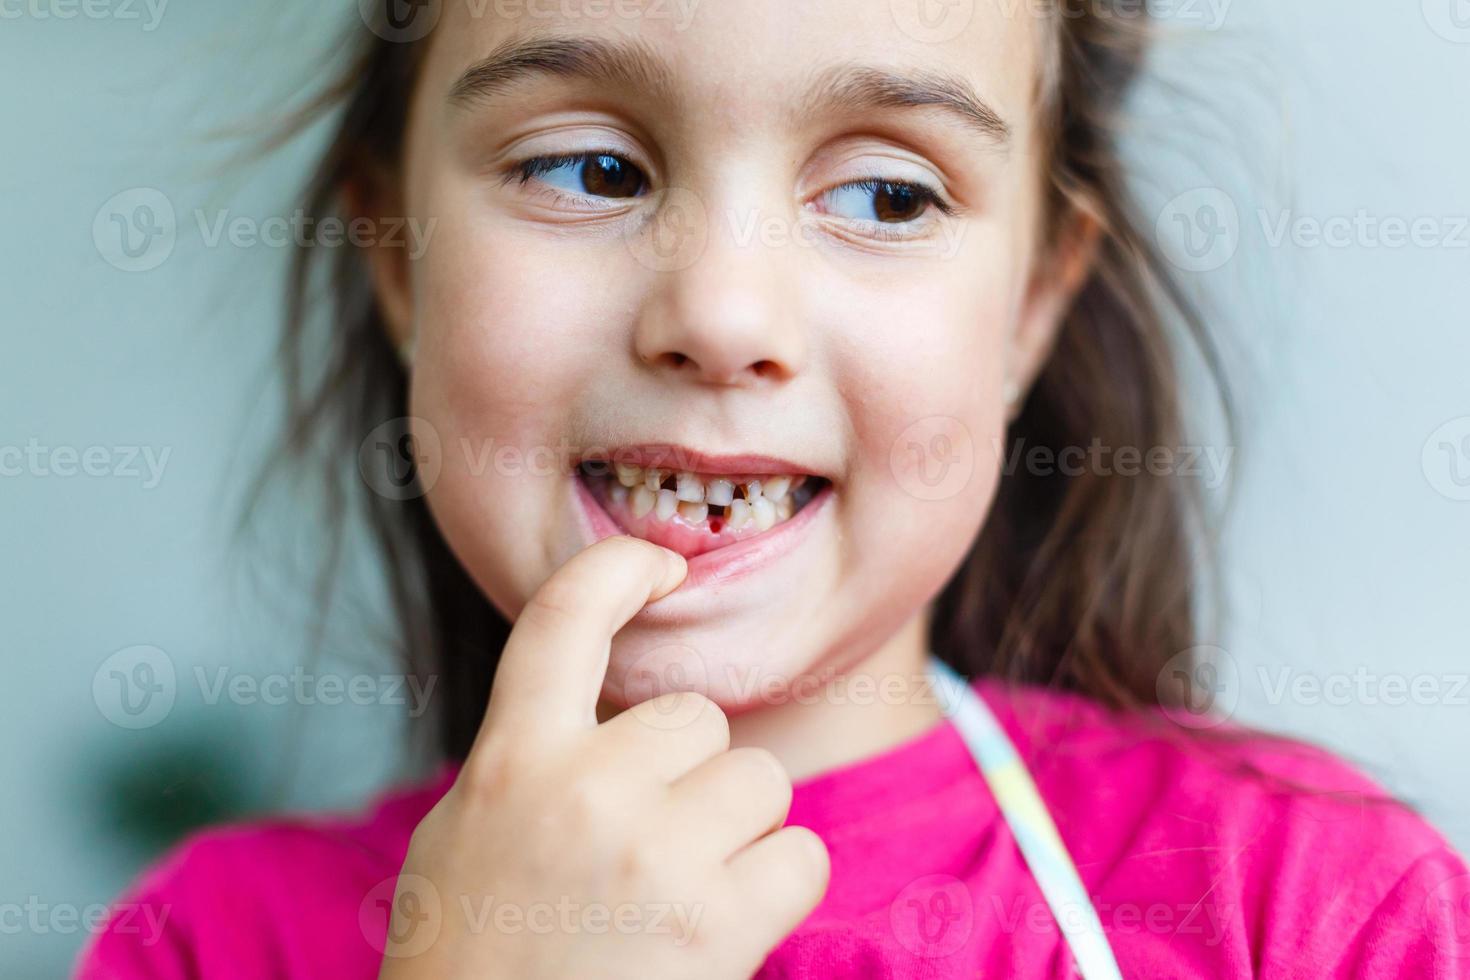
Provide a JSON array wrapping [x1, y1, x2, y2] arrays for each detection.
[[81, 682, 1470, 980]]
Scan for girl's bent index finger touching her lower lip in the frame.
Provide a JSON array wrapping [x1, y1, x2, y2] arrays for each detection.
[[476, 536, 688, 742]]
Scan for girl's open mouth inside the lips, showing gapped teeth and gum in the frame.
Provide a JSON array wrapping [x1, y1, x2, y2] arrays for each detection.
[[578, 460, 831, 558]]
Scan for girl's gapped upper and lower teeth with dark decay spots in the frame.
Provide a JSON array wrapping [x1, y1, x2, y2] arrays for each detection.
[[593, 463, 807, 530]]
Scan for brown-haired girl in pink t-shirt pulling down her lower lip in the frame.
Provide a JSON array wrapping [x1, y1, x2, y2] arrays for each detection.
[[82, 0, 1470, 979]]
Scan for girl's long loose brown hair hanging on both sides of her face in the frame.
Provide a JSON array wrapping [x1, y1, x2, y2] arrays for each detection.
[[256, 0, 1229, 758]]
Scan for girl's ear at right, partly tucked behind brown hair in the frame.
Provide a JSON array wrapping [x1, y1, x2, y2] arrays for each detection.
[[1007, 204, 1101, 411]]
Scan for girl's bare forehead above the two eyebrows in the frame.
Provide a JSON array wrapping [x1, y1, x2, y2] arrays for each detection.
[[420, 0, 1047, 137]]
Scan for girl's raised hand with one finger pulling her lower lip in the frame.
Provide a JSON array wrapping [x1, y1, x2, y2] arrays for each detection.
[[381, 538, 829, 980]]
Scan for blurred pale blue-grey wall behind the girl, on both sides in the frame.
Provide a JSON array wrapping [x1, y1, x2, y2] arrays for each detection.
[[0, 0, 1470, 977]]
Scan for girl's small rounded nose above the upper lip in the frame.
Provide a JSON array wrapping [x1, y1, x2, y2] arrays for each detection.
[[634, 202, 807, 388]]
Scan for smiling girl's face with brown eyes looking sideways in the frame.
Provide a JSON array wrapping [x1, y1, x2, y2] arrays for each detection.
[[375, 0, 1087, 708]]
